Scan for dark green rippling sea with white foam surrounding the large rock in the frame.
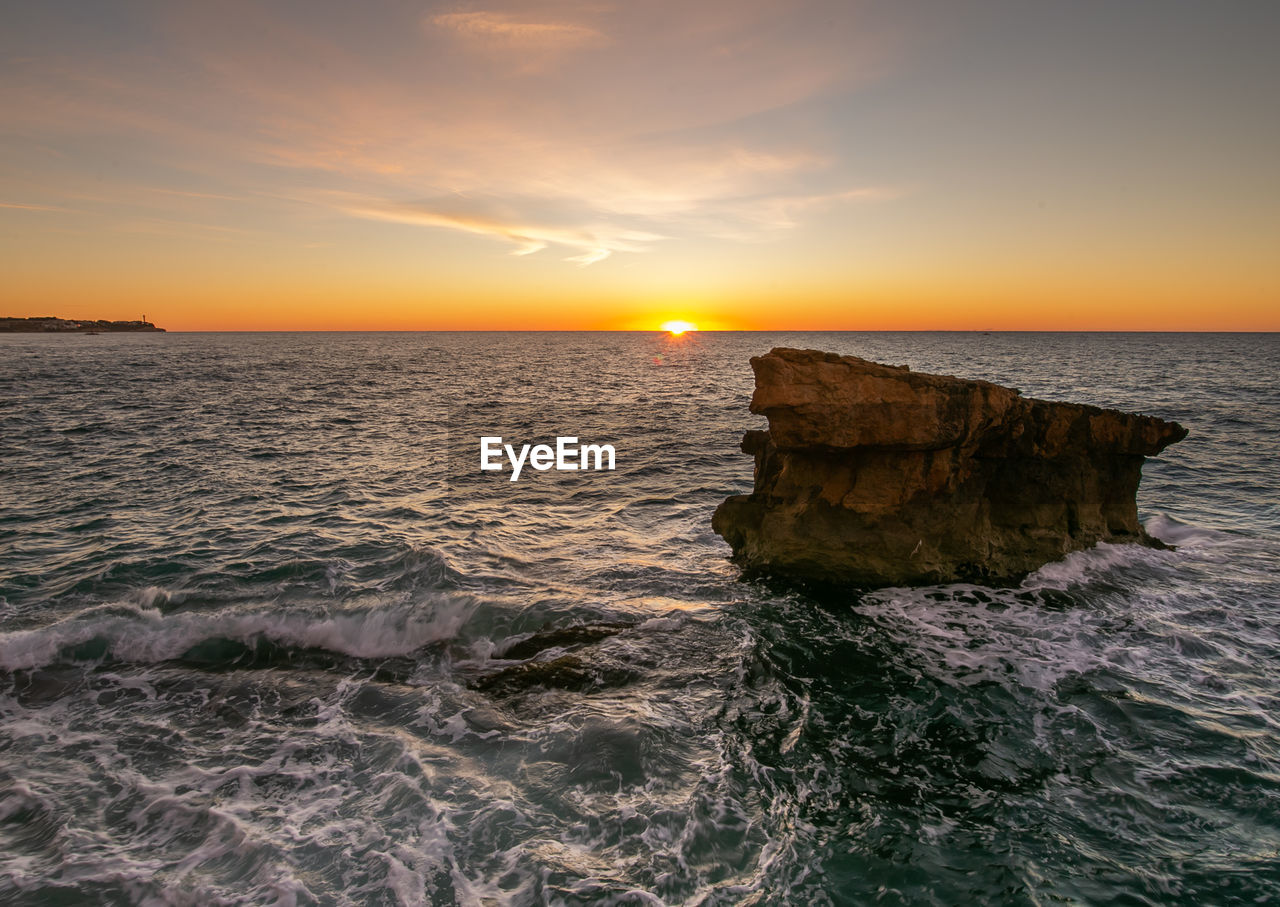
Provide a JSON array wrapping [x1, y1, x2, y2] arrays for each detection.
[[0, 334, 1280, 904]]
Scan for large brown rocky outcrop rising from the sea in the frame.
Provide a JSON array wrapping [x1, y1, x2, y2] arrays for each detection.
[[712, 348, 1187, 587]]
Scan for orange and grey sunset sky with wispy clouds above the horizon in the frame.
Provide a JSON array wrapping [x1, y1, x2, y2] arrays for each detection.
[[0, 0, 1280, 330]]
